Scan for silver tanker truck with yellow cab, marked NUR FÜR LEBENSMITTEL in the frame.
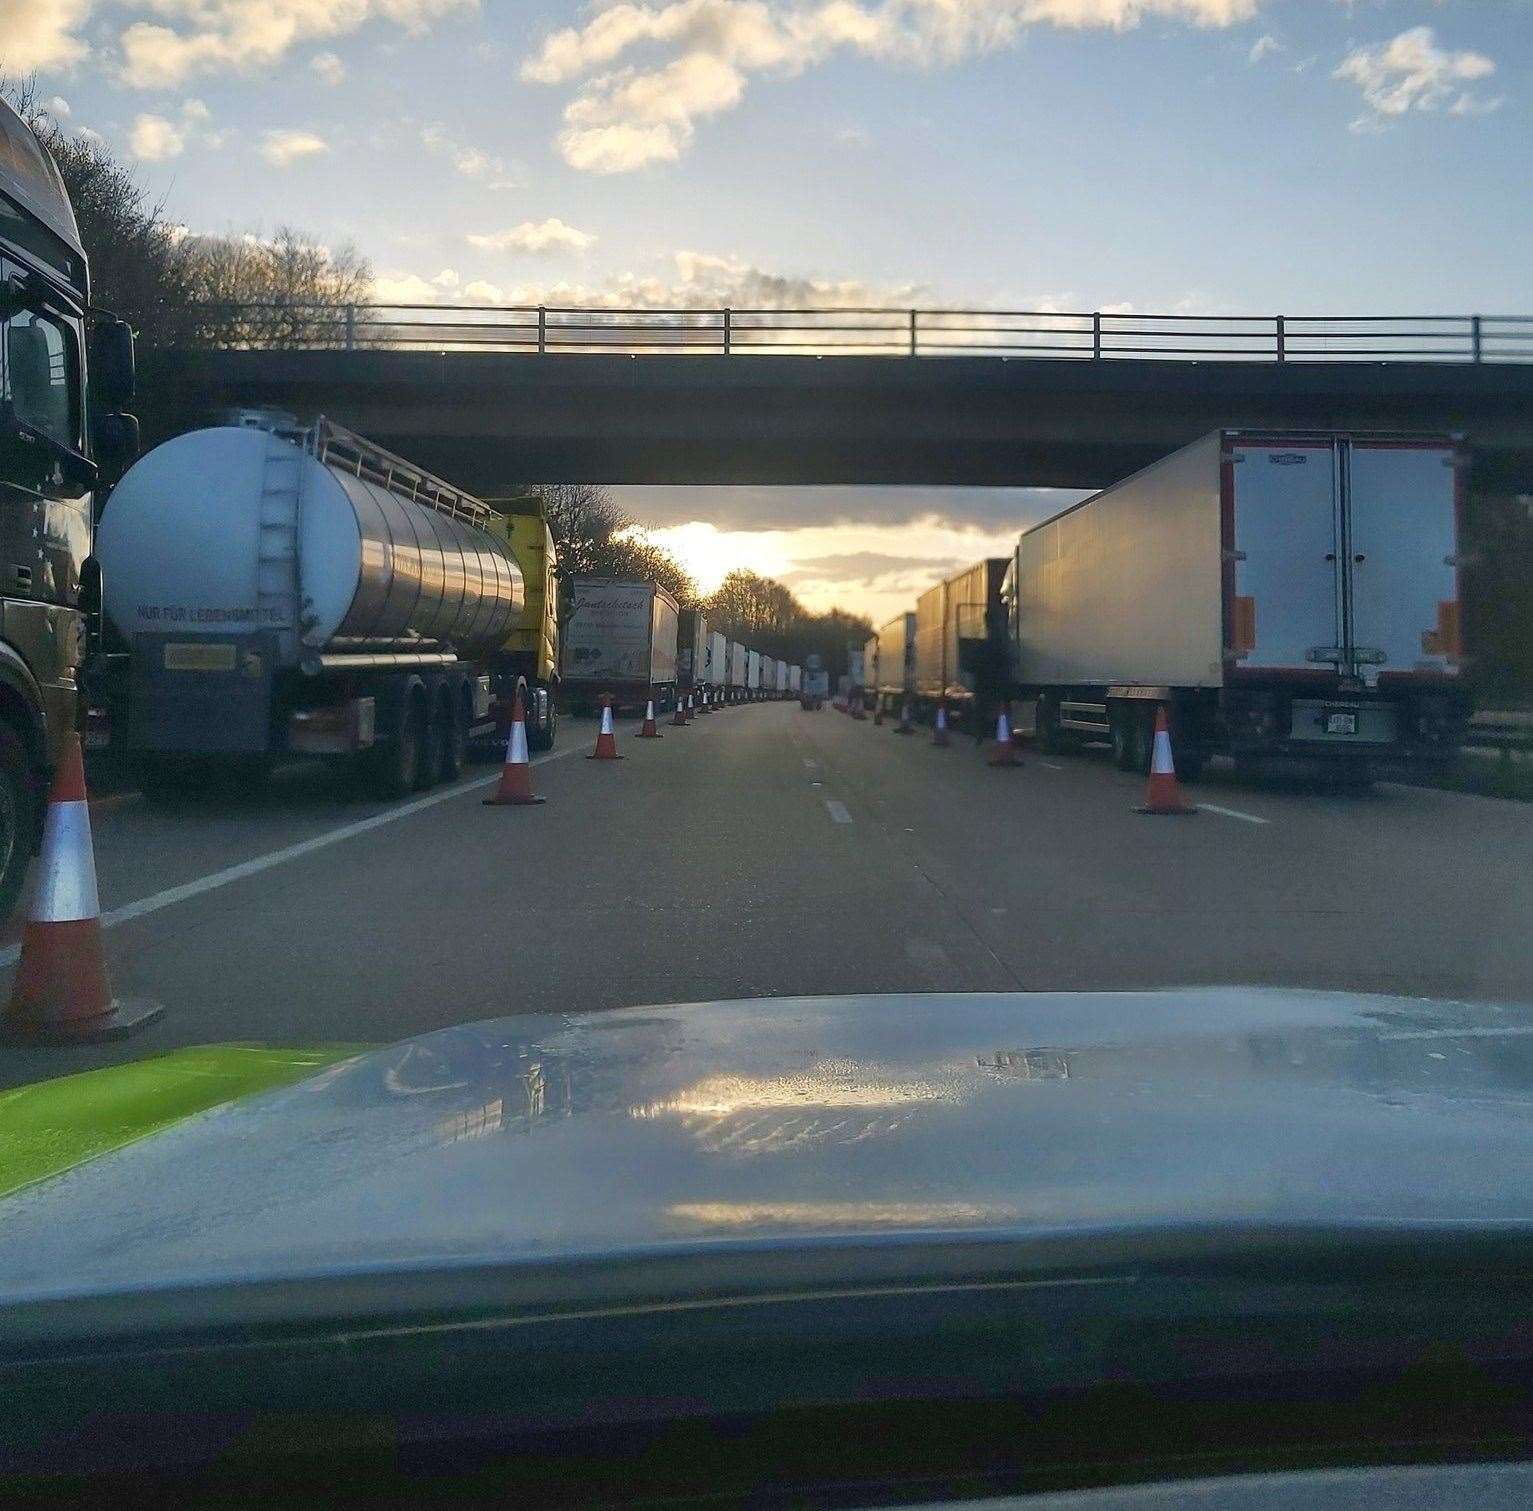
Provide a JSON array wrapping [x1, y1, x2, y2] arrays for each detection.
[[97, 411, 556, 798]]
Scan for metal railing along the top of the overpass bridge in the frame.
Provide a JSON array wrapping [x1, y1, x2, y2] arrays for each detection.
[[138, 303, 1533, 363]]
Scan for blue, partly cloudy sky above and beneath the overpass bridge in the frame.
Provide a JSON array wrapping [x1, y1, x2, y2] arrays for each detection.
[[9, 0, 1533, 618]]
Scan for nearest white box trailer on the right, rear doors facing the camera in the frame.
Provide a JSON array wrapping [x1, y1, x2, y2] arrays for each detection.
[[1004, 431, 1470, 780]]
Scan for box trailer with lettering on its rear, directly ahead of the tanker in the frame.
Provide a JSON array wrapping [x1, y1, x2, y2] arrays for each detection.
[[564, 576, 681, 713]]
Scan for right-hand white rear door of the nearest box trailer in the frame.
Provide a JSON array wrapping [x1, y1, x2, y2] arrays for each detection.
[[1343, 441, 1458, 679]]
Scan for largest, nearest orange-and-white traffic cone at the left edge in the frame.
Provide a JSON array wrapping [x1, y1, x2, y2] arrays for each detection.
[[5, 734, 164, 1044]]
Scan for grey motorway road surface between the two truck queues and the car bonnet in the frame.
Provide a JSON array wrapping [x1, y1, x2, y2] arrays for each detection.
[[0, 703, 1533, 1085]]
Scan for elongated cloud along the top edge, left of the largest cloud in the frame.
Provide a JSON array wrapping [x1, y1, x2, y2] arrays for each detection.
[[115, 0, 478, 89]]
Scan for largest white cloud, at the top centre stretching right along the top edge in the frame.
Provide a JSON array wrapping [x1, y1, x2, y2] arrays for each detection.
[[521, 0, 1259, 173]]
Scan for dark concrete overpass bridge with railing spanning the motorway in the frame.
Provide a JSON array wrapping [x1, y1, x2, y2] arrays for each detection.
[[134, 306, 1533, 493]]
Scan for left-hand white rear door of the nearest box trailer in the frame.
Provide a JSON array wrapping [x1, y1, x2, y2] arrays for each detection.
[[1226, 441, 1341, 671]]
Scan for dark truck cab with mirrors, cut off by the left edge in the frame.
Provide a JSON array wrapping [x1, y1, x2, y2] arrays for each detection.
[[0, 101, 138, 916]]
